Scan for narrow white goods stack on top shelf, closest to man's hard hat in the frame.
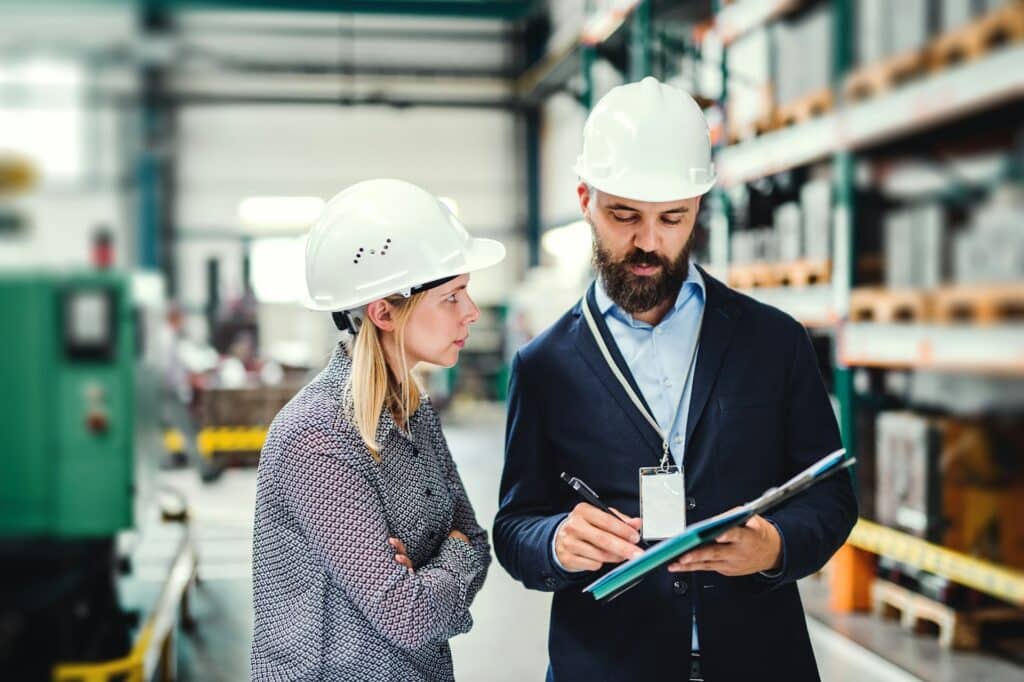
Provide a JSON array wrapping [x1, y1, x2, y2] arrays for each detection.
[[725, 28, 772, 141]]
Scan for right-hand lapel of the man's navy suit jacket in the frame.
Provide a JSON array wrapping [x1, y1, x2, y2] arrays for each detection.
[[686, 269, 739, 440]]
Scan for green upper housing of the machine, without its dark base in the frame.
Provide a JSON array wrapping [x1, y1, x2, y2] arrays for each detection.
[[0, 271, 135, 540]]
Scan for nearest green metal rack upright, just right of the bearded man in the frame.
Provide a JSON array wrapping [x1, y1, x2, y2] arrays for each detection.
[[833, 0, 856, 458]]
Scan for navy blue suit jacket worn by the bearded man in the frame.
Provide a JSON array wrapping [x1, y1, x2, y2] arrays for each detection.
[[494, 272, 857, 682]]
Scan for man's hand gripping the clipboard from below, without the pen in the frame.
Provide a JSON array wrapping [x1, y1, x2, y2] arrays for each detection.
[[669, 516, 782, 576]]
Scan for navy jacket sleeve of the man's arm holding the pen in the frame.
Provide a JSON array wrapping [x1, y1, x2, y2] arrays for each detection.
[[495, 353, 594, 591]]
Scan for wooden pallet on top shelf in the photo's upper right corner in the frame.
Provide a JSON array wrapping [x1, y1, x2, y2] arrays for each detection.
[[928, 2, 1024, 70]]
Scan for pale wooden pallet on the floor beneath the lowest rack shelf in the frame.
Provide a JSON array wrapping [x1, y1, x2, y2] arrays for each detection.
[[871, 579, 1024, 649]]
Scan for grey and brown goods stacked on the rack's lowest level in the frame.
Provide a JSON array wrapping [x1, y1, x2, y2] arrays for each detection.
[[874, 412, 1024, 568]]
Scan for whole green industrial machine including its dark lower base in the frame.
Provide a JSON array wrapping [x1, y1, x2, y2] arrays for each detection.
[[0, 270, 158, 680]]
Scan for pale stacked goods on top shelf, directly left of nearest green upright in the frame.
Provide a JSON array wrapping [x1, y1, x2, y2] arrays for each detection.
[[772, 2, 834, 126]]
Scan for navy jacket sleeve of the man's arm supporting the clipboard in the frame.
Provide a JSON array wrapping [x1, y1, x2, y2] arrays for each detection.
[[764, 325, 857, 585]]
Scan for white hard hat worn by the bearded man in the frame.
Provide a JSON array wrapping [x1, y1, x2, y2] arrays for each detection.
[[573, 76, 716, 202]]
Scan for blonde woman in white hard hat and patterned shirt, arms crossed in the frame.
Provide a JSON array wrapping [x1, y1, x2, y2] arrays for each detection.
[[251, 180, 505, 682]]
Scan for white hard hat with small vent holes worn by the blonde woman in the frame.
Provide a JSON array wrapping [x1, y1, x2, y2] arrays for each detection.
[[305, 179, 505, 311]]
